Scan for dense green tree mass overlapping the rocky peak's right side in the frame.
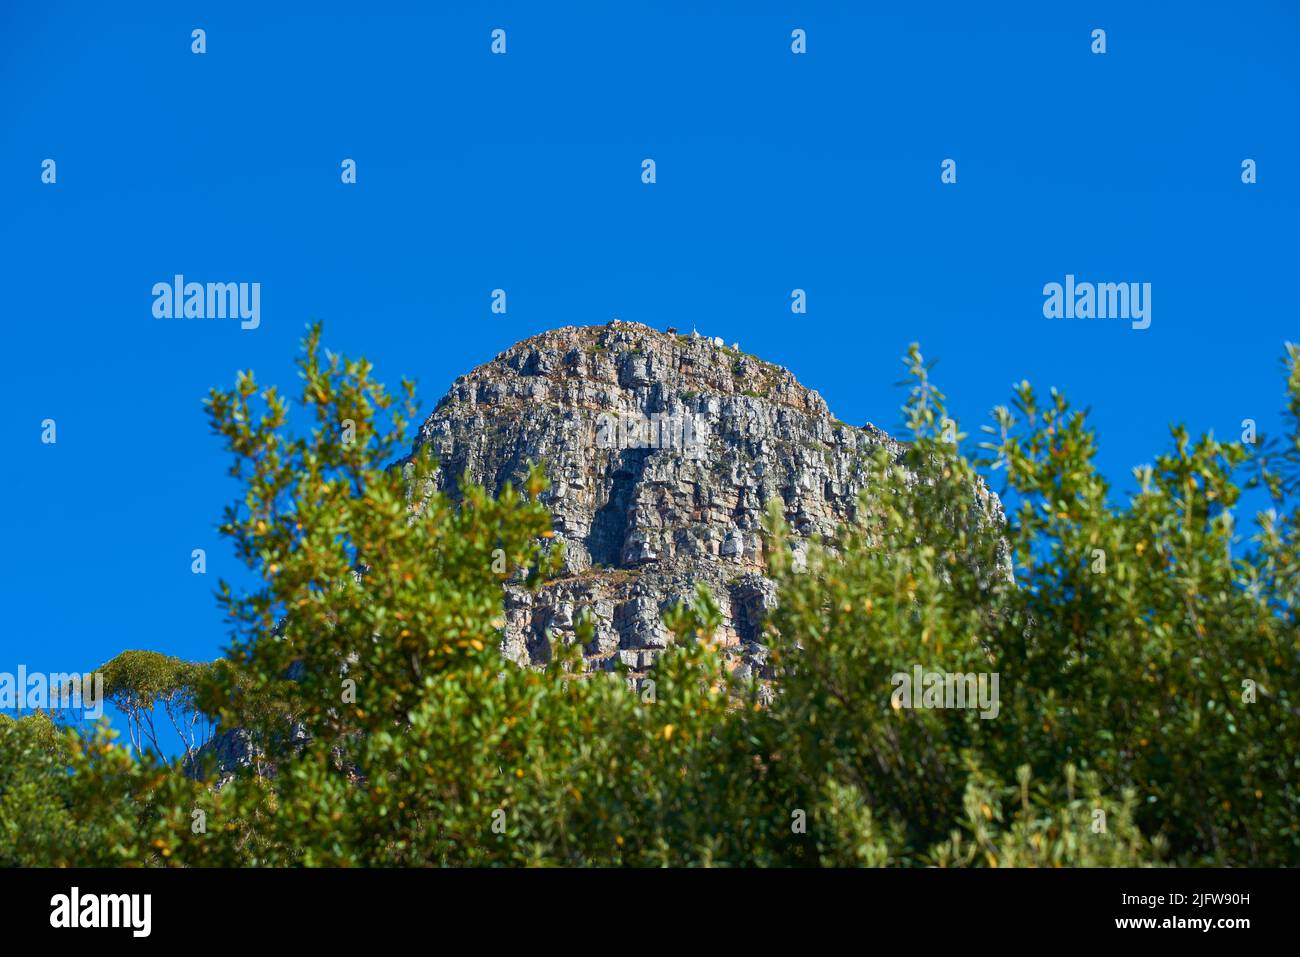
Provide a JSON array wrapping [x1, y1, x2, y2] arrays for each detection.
[[771, 347, 1300, 865]]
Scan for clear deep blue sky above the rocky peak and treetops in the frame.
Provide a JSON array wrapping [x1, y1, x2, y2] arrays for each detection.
[[0, 0, 1300, 733]]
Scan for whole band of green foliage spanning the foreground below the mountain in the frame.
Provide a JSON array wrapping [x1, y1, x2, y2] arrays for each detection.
[[0, 329, 1300, 867]]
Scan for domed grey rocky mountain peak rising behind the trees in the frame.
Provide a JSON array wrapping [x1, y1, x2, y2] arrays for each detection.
[[405, 321, 905, 675]]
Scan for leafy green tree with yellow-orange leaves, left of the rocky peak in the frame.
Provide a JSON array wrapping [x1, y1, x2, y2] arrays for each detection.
[[150, 323, 770, 865]]
